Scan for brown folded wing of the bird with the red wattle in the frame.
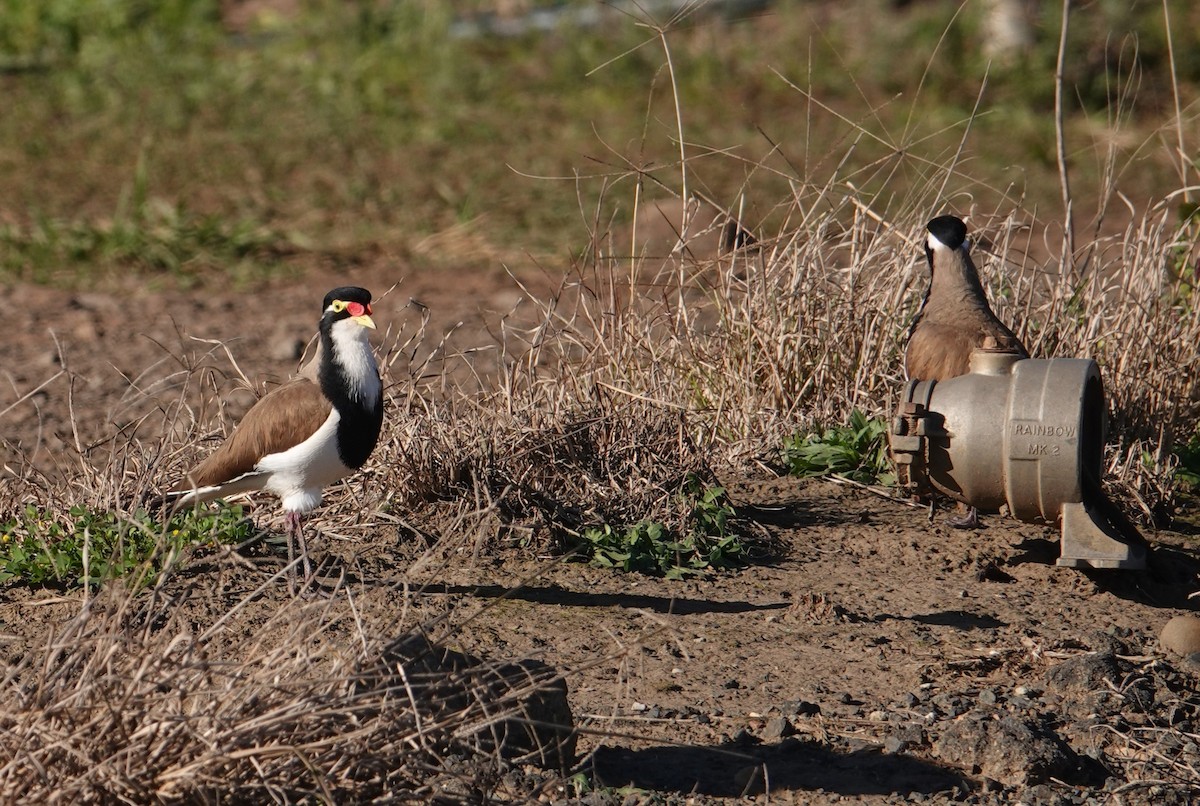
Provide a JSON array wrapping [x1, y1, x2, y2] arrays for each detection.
[[175, 378, 332, 492]]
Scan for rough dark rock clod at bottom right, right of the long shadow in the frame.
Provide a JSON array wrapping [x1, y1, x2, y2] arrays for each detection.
[[934, 711, 1078, 787]]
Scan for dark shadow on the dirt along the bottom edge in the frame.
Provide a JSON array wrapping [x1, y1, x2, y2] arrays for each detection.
[[590, 738, 971, 798]]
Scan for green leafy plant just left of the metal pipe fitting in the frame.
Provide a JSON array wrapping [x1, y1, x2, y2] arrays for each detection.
[[784, 409, 895, 487]]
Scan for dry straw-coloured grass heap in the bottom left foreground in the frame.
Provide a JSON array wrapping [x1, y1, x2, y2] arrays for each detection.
[[0, 575, 571, 802]]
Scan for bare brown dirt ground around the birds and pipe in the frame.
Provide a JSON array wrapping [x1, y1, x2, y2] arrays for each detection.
[[0, 262, 1200, 804]]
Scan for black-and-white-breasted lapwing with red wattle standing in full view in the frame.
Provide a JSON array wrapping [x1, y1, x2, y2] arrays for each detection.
[[167, 285, 383, 593]]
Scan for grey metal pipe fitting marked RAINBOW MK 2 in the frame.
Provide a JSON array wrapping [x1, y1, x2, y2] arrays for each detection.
[[890, 349, 1146, 569]]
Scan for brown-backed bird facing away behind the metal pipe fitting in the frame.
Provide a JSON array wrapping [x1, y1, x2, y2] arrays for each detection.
[[904, 216, 1030, 529]]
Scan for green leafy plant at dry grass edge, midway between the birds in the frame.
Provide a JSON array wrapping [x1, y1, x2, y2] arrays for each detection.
[[582, 474, 745, 579]]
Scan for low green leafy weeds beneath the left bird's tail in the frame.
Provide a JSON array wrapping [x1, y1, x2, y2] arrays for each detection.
[[0, 505, 254, 587]]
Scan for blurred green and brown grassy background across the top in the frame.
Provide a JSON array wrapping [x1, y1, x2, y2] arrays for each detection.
[[0, 0, 1200, 284]]
